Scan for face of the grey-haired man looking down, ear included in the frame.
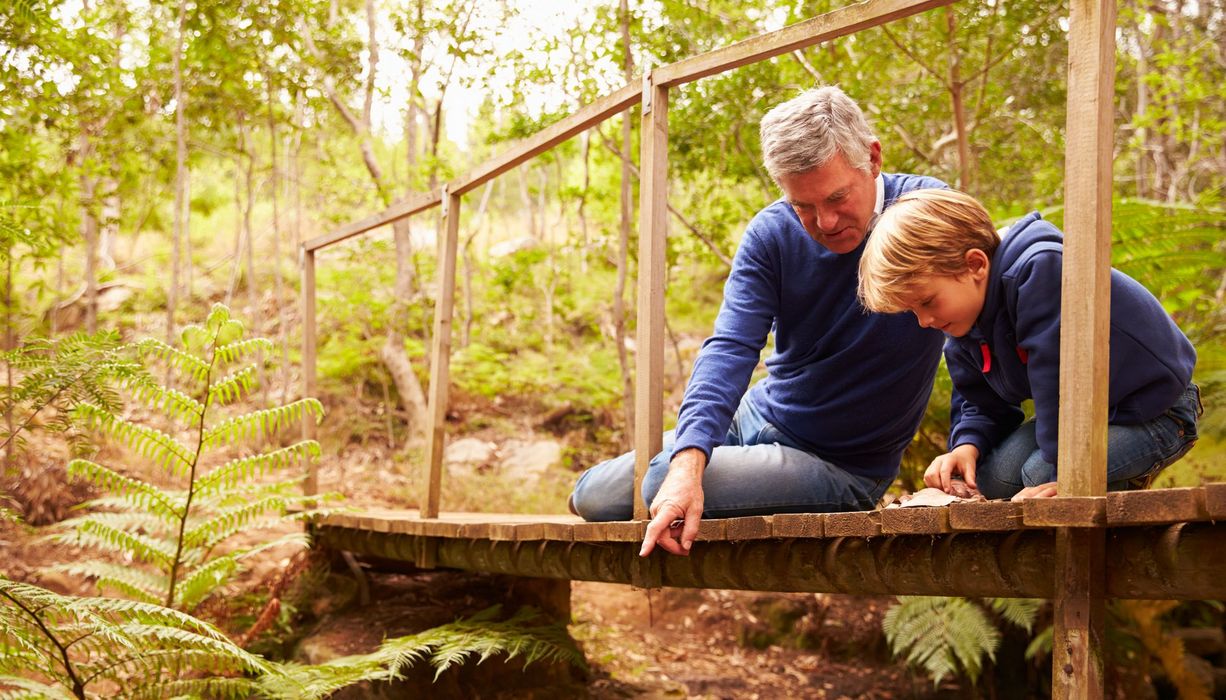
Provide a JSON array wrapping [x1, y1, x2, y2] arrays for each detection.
[[779, 142, 881, 255]]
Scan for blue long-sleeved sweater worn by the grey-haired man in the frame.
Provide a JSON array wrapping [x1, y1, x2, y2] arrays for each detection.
[[673, 174, 945, 478]]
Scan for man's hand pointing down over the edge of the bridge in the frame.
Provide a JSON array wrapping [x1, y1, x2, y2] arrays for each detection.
[[639, 449, 706, 557]]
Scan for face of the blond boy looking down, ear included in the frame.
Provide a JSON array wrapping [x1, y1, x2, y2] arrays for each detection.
[[902, 250, 989, 338]]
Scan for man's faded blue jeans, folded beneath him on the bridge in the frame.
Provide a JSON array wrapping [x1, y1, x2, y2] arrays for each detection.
[[571, 398, 894, 521]]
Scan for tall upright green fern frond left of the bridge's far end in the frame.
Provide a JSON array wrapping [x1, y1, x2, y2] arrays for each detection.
[[46, 304, 322, 611]]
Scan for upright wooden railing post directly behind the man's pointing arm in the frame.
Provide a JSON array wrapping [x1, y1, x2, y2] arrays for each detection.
[[634, 78, 668, 520]]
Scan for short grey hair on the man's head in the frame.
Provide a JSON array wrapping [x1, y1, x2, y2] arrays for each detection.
[[759, 86, 877, 183]]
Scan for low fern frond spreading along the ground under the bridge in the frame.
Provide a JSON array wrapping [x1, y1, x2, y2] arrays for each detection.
[[261, 606, 584, 700]]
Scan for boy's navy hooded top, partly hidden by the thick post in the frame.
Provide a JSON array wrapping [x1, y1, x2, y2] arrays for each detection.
[[945, 212, 1197, 465]]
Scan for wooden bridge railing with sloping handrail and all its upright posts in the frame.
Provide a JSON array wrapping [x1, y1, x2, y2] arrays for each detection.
[[302, 0, 1116, 698]]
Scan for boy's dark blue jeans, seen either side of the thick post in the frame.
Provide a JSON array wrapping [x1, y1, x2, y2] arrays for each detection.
[[975, 384, 1203, 498]]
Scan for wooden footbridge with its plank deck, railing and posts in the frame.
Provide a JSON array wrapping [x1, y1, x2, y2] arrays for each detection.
[[302, 0, 1226, 698]]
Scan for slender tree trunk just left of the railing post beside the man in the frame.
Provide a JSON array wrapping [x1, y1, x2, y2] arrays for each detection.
[[613, 0, 635, 450]]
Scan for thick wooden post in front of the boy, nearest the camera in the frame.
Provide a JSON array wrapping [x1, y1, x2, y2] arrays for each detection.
[[1052, 0, 1116, 699]]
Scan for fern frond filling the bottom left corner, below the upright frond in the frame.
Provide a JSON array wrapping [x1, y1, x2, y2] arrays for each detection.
[[0, 576, 275, 699]]
